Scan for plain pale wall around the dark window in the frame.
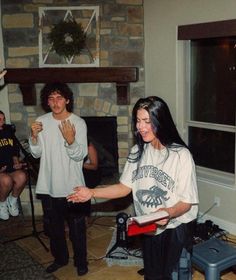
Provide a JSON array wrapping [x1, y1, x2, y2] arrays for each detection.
[[144, 0, 236, 234]]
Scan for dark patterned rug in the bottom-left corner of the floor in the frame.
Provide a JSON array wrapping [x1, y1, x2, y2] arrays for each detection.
[[0, 238, 57, 280]]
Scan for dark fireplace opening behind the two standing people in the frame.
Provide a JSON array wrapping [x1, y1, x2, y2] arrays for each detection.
[[82, 117, 118, 177]]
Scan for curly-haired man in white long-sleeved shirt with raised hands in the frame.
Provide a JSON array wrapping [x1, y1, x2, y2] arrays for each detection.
[[29, 83, 88, 275]]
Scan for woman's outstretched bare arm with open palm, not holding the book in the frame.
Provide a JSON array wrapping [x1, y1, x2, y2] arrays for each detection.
[[67, 183, 132, 202]]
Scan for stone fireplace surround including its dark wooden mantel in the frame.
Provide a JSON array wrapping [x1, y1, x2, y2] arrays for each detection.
[[1, 0, 145, 217]]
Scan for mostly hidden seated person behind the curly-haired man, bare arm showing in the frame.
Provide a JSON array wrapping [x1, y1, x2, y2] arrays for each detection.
[[83, 137, 101, 188]]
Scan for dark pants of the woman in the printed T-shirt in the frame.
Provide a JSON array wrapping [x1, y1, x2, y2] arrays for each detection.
[[143, 222, 194, 280]]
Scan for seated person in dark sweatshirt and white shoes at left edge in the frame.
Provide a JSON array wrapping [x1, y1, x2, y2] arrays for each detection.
[[0, 111, 27, 220]]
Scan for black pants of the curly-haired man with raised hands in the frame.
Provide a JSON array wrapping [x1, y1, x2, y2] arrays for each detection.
[[39, 195, 90, 270]]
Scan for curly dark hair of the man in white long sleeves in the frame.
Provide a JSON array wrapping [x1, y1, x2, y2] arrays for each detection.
[[40, 82, 74, 112]]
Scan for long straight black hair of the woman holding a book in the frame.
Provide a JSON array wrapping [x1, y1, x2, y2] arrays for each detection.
[[132, 96, 188, 161]]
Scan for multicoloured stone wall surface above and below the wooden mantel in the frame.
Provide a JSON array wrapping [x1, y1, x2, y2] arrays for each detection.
[[1, 0, 144, 217]]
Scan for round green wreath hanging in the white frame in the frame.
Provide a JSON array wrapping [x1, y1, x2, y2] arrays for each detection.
[[48, 20, 86, 58]]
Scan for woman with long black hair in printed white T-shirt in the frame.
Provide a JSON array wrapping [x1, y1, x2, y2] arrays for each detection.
[[67, 96, 198, 280]]
